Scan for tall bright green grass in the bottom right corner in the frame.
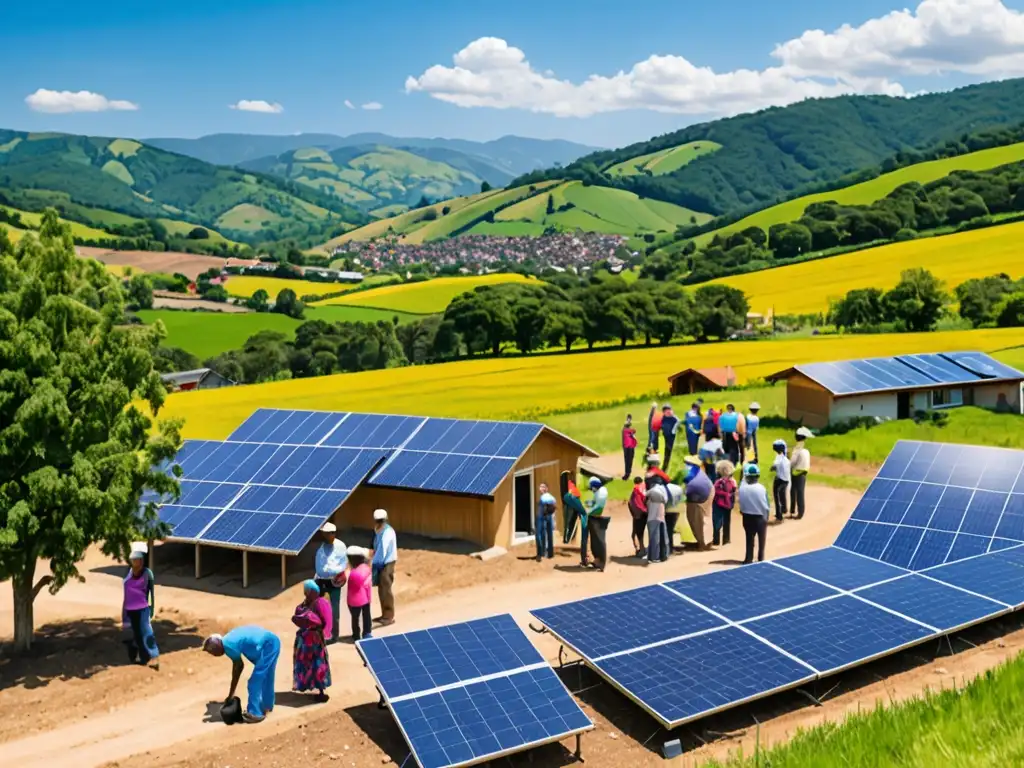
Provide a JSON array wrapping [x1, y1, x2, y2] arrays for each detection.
[[702, 656, 1024, 768]]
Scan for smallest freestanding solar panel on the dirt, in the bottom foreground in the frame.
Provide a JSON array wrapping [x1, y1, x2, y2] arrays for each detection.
[[357, 613, 594, 768]]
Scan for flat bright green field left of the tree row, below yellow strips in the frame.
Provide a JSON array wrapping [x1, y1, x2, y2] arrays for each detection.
[[138, 306, 420, 360]]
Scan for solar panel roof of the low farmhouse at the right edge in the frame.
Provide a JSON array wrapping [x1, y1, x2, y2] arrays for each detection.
[[796, 352, 1024, 395]]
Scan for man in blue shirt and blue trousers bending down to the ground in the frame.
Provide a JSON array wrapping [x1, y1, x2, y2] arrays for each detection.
[[203, 625, 281, 723]]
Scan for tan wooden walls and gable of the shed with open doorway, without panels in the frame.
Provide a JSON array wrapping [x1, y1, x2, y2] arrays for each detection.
[[333, 427, 598, 548]]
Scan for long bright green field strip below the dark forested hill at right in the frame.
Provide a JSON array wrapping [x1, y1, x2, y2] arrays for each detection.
[[693, 142, 1024, 246]]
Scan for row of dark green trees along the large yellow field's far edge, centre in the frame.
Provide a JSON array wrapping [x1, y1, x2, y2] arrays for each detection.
[[193, 275, 749, 383]]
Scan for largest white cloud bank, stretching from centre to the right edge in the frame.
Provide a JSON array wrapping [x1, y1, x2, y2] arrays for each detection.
[[406, 0, 1024, 117]]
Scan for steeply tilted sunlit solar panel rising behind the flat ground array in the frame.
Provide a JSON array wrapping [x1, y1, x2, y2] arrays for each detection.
[[836, 440, 1024, 570]]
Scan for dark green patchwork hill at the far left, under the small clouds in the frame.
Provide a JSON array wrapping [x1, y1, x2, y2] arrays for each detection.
[[0, 130, 369, 243]]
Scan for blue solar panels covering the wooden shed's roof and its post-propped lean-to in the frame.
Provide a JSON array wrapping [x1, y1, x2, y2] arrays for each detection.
[[151, 409, 543, 554]]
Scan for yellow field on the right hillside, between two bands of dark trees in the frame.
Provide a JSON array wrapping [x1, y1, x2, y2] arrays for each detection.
[[715, 222, 1024, 314]]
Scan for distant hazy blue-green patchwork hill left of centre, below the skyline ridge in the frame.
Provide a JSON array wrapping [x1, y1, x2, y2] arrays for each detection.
[[242, 144, 512, 214]]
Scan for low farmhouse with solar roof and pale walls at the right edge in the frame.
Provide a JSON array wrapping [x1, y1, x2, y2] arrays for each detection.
[[768, 352, 1024, 427]]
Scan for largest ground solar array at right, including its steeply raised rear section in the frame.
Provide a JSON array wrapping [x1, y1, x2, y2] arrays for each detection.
[[531, 441, 1024, 728]]
